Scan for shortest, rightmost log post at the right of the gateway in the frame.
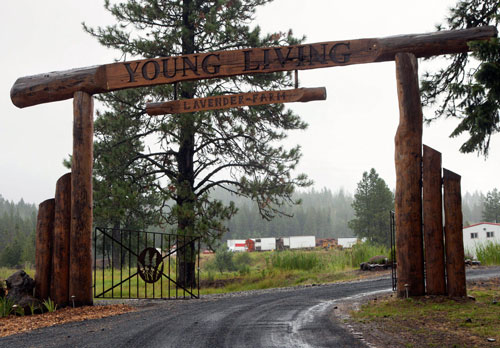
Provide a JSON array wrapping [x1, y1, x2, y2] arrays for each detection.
[[443, 169, 467, 297]]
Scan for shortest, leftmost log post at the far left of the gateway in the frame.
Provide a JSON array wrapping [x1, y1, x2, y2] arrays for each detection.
[[35, 198, 55, 300]]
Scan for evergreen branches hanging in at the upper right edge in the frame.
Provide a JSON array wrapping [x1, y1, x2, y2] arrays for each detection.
[[421, 0, 500, 156]]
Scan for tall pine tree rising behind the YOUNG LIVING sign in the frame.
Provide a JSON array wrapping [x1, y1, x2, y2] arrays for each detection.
[[85, 0, 309, 285]]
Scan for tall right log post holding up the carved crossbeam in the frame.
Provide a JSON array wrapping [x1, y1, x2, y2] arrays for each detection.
[[395, 53, 425, 297]]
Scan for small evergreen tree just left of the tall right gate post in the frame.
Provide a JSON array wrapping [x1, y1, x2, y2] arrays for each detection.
[[349, 168, 394, 246]]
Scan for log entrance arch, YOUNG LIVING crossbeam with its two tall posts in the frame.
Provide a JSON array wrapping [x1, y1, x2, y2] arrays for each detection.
[[11, 27, 497, 304]]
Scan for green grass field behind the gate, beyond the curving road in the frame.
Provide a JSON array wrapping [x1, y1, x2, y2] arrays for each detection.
[[0, 244, 389, 298]]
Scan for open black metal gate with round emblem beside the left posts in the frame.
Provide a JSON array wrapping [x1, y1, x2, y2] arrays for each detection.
[[93, 227, 200, 299]]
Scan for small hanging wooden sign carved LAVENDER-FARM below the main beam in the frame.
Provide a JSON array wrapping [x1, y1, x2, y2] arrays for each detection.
[[146, 87, 326, 115]]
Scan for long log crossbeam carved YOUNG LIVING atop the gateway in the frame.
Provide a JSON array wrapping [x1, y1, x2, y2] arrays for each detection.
[[11, 26, 497, 107]]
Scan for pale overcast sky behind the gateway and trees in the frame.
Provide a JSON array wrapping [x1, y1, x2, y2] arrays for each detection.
[[0, 0, 500, 204]]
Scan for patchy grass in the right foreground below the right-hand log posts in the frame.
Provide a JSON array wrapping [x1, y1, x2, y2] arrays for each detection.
[[352, 278, 500, 348]]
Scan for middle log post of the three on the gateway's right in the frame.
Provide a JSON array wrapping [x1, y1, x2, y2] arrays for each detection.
[[422, 145, 446, 295]]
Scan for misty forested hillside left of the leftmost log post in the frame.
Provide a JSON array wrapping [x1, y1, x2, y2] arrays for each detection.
[[0, 195, 37, 267]]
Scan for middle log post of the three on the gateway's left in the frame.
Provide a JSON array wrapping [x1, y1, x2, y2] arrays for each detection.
[[50, 173, 71, 307]]
